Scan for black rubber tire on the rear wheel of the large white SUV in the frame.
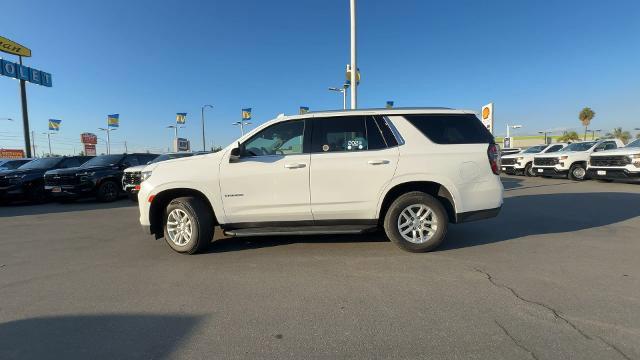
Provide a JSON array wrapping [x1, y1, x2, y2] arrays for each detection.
[[384, 191, 449, 252]]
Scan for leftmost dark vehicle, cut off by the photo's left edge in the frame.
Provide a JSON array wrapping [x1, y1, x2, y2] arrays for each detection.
[[0, 156, 91, 202]]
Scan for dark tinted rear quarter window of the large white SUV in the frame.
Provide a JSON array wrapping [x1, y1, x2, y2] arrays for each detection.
[[404, 114, 495, 144]]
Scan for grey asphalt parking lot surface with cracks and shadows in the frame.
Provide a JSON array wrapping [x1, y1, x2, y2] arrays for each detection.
[[0, 177, 640, 359]]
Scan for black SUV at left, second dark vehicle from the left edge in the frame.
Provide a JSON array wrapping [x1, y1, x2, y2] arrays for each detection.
[[44, 154, 158, 202]]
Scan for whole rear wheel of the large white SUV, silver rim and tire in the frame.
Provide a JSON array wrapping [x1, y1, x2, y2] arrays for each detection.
[[384, 191, 449, 252]]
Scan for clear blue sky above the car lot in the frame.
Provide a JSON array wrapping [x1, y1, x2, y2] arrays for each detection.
[[0, 0, 640, 153]]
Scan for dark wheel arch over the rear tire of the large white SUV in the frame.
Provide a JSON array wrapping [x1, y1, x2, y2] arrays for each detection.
[[378, 181, 456, 224]]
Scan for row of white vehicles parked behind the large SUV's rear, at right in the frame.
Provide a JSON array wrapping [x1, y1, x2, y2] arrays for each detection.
[[501, 139, 640, 181]]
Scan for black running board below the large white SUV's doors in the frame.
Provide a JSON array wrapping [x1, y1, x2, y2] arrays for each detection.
[[224, 225, 376, 237]]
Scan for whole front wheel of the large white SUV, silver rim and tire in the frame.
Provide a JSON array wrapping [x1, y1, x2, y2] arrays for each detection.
[[164, 196, 214, 254]]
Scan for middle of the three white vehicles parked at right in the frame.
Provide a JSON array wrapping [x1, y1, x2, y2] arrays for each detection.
[[533, 139, 624, 181]]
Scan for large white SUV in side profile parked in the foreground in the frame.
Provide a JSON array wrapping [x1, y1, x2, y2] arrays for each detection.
[[138, 108, 503, 254]]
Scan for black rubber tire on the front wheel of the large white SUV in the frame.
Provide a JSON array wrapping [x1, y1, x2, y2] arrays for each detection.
[[164, 196, 215, 254]]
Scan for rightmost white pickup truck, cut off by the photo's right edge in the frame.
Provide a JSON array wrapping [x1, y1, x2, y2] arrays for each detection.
[[587, 139, 640, 181]]
